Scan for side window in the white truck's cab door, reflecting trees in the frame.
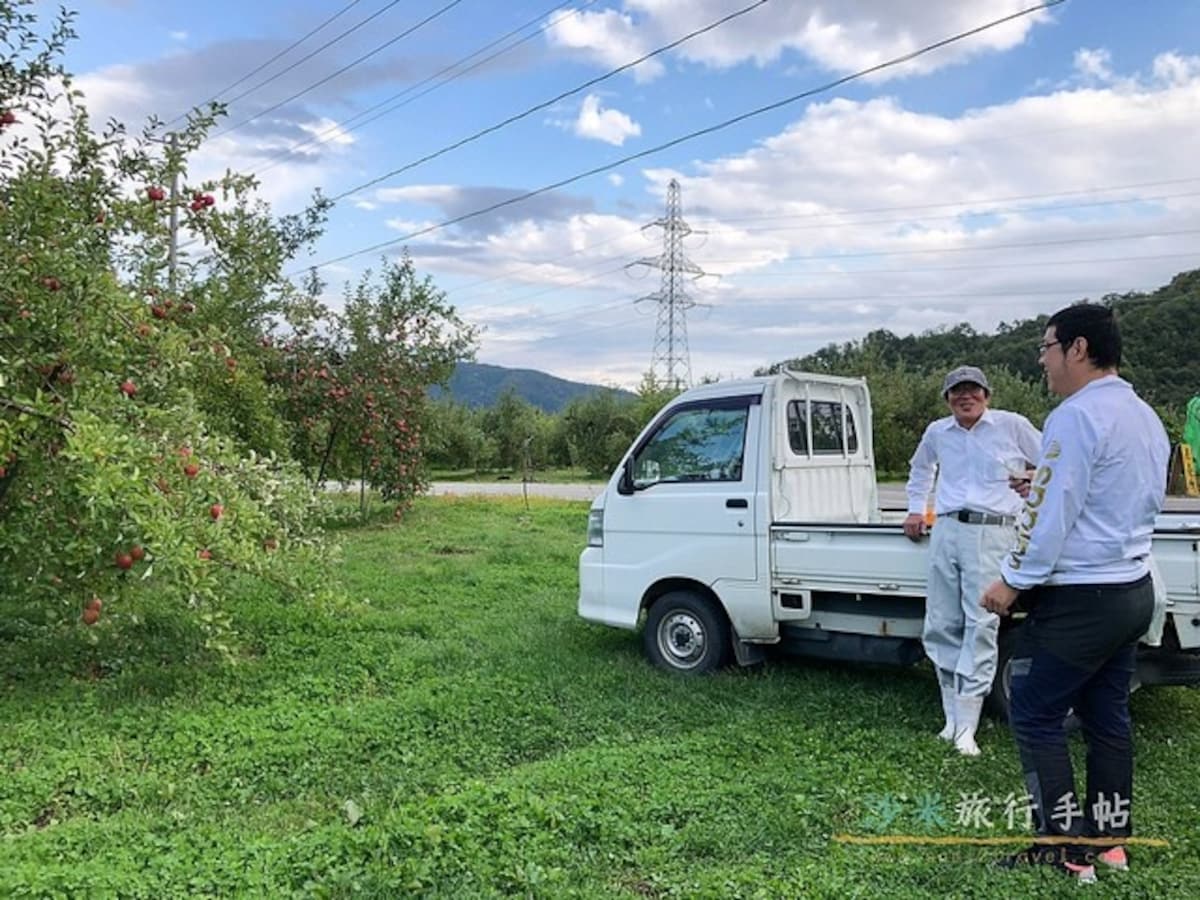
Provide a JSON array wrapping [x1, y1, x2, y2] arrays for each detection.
[[634, 407, 750, 487]]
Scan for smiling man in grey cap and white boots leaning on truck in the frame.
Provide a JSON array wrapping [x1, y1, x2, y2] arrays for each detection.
[[904, 366, 1042, 756]]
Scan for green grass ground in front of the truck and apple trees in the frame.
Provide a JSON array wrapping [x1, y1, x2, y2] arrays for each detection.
[[0, 499, 1200, 898]]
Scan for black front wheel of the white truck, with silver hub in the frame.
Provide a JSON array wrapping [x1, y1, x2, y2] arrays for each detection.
[[642, 590, 731, 674]]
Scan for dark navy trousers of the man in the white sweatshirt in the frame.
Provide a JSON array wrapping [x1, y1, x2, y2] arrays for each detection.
[[1010, 577, 1154, 856]]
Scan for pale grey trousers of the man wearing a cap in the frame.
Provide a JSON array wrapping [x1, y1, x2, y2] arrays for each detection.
[[922, 517, 1014, 697]]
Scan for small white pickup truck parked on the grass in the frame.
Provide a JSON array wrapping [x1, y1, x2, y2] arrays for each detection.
[[578, 371, 1200, 718]]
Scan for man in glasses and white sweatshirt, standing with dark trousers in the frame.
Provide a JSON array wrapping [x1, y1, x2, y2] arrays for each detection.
[[980, 304, 1170, 881]]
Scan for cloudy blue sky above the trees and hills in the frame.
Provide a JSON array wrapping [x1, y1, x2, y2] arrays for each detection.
[[51, 0, 1200, 386]]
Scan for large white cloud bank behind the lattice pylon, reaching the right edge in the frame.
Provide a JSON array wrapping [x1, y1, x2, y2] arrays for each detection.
[[420, 54, 1200, 386]]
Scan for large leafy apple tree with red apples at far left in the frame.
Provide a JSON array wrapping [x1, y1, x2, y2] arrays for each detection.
[[0, 2, 328, 648]]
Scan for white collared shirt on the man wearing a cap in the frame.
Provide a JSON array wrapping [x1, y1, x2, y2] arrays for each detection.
[[906, 409, 1042, 516]]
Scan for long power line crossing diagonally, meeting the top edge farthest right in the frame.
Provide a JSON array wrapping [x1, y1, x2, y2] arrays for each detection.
[[300, 0, 1066, 269]]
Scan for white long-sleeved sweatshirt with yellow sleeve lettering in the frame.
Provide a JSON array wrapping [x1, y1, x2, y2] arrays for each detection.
[[1001, 374, 1171, 589]]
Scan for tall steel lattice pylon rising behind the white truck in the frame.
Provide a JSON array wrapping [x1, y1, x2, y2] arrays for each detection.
[[626, 179, 704, 390]]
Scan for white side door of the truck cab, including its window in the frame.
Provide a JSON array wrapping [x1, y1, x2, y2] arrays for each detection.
[[604, 395, 762, 599]]
